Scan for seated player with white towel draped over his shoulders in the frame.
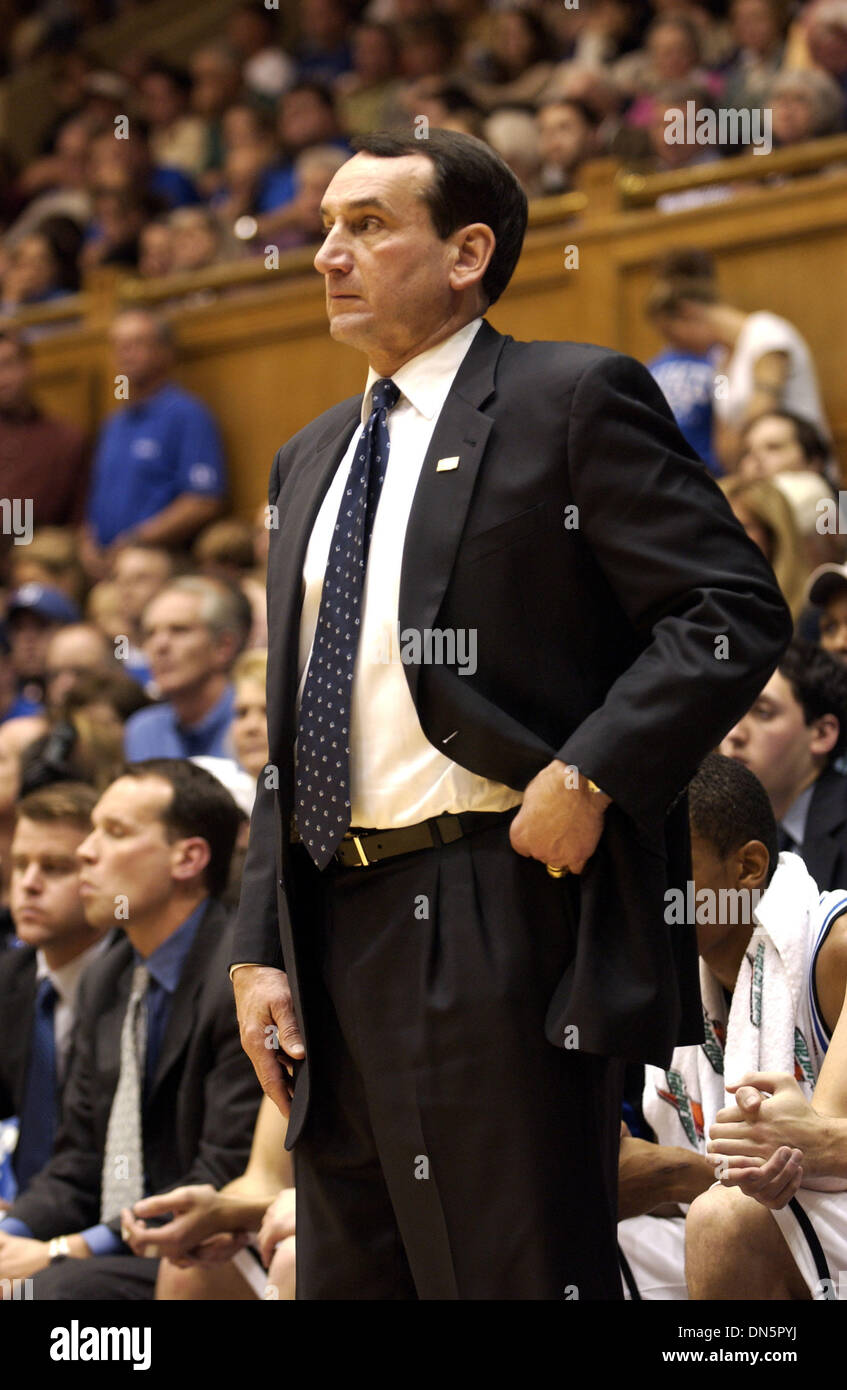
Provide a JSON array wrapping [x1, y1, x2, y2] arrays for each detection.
[[618, 753, 847, 1300]]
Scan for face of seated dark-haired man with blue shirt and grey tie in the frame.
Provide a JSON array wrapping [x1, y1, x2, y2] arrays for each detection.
[[76, 776, 178, 927]]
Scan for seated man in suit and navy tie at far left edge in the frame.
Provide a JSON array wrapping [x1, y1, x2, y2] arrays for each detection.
[[0, 783, 108, 1194]]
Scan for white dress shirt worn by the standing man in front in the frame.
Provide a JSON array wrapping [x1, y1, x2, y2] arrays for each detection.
[[298, 318, 523, 830]]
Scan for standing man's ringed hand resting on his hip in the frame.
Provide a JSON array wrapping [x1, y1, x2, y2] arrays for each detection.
[[509, 758, 612, 867]]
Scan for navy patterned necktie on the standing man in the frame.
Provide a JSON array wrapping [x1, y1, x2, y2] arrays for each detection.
[[296, 377, 401, 869]]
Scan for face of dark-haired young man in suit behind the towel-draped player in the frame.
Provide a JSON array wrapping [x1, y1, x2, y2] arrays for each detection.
[[720, 671, 818, 813]]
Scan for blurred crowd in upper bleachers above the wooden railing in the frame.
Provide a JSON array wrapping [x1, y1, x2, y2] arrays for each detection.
[[0, 0, 847, 307]]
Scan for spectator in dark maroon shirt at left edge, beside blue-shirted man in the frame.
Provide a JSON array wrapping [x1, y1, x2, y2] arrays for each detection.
[[0, 328, 89, 527]]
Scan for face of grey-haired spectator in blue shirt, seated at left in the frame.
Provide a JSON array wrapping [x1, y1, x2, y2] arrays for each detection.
[[142, 589, 232, 699]]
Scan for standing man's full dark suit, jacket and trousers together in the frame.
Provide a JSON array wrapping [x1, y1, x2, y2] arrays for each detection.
[[232, 322, 791, 1298]]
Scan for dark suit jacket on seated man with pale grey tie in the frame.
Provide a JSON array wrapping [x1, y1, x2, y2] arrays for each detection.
[[10, 901, 261, 1240]]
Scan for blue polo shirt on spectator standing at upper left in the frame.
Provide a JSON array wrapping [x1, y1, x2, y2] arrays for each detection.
[[88, 384, 227, 545]]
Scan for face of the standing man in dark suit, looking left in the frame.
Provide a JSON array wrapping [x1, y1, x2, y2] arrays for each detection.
[[314, 154, 456, 363]]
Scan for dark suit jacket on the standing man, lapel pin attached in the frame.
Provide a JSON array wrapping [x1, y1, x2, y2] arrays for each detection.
[[232, 324, 791, 1147]]
